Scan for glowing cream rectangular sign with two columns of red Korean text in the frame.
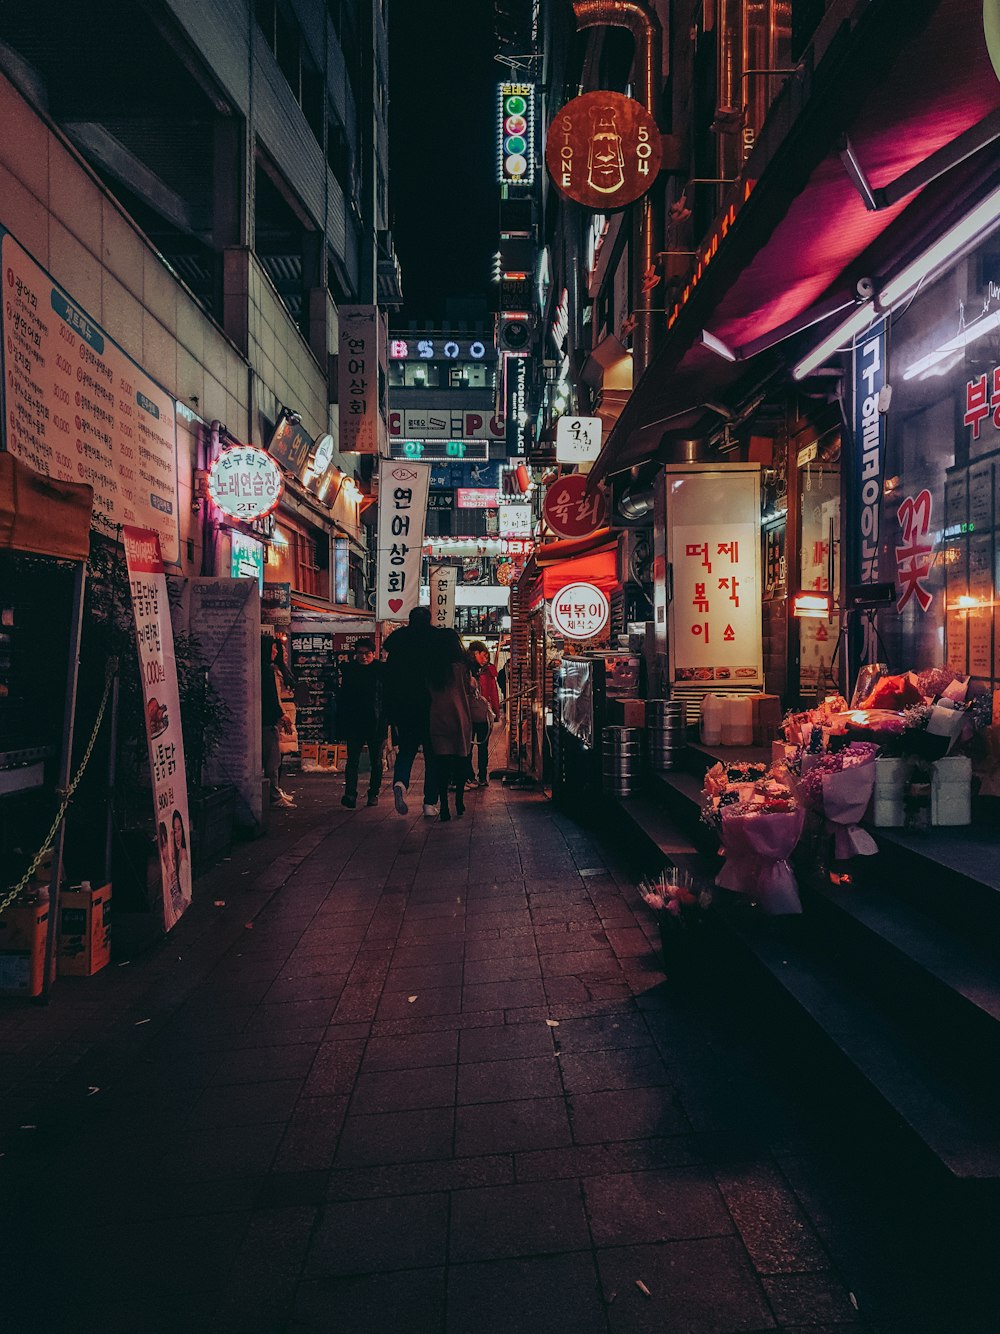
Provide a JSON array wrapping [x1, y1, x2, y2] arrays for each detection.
[[667, 466, 764, 686]]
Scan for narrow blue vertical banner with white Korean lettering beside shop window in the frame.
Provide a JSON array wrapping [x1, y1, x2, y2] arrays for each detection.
[[848, 316, 888, 670]]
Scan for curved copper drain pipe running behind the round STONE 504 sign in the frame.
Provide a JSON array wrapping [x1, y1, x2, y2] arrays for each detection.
[[573, 0, 664, 380]]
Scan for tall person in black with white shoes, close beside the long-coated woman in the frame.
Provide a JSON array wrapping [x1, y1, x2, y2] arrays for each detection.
[[384, 607, 439, 818]]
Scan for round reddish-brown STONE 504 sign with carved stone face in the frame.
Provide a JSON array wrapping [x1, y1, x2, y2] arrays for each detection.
[[545, 92, 663, 213]]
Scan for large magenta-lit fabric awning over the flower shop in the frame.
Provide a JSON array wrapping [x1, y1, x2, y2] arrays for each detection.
[[591, 0, 1000, 484]]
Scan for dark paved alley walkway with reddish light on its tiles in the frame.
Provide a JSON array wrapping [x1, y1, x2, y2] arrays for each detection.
[[0, 757, 996, 1334]]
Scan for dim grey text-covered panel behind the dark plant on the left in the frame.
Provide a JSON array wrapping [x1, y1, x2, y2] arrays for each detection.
[[184, 576, 261, 823]]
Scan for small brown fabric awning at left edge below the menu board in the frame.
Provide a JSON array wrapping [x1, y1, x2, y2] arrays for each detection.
[[0, 454, 93, 560]]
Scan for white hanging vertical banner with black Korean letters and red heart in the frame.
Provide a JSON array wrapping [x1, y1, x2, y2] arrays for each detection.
[[376, 460, 431, 620]]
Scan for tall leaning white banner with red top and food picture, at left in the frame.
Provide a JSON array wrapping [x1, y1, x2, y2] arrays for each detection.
[[123, 527, 191, 931]]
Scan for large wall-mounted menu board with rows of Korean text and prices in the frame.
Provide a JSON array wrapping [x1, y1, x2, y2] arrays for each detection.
[[0, 228, 180, 564]]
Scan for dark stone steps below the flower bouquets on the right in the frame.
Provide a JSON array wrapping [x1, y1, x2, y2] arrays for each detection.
[[619, 744, 1000, 1195]]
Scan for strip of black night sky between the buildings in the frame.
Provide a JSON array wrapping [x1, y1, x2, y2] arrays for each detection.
[[389, 0, 504, 323]]
